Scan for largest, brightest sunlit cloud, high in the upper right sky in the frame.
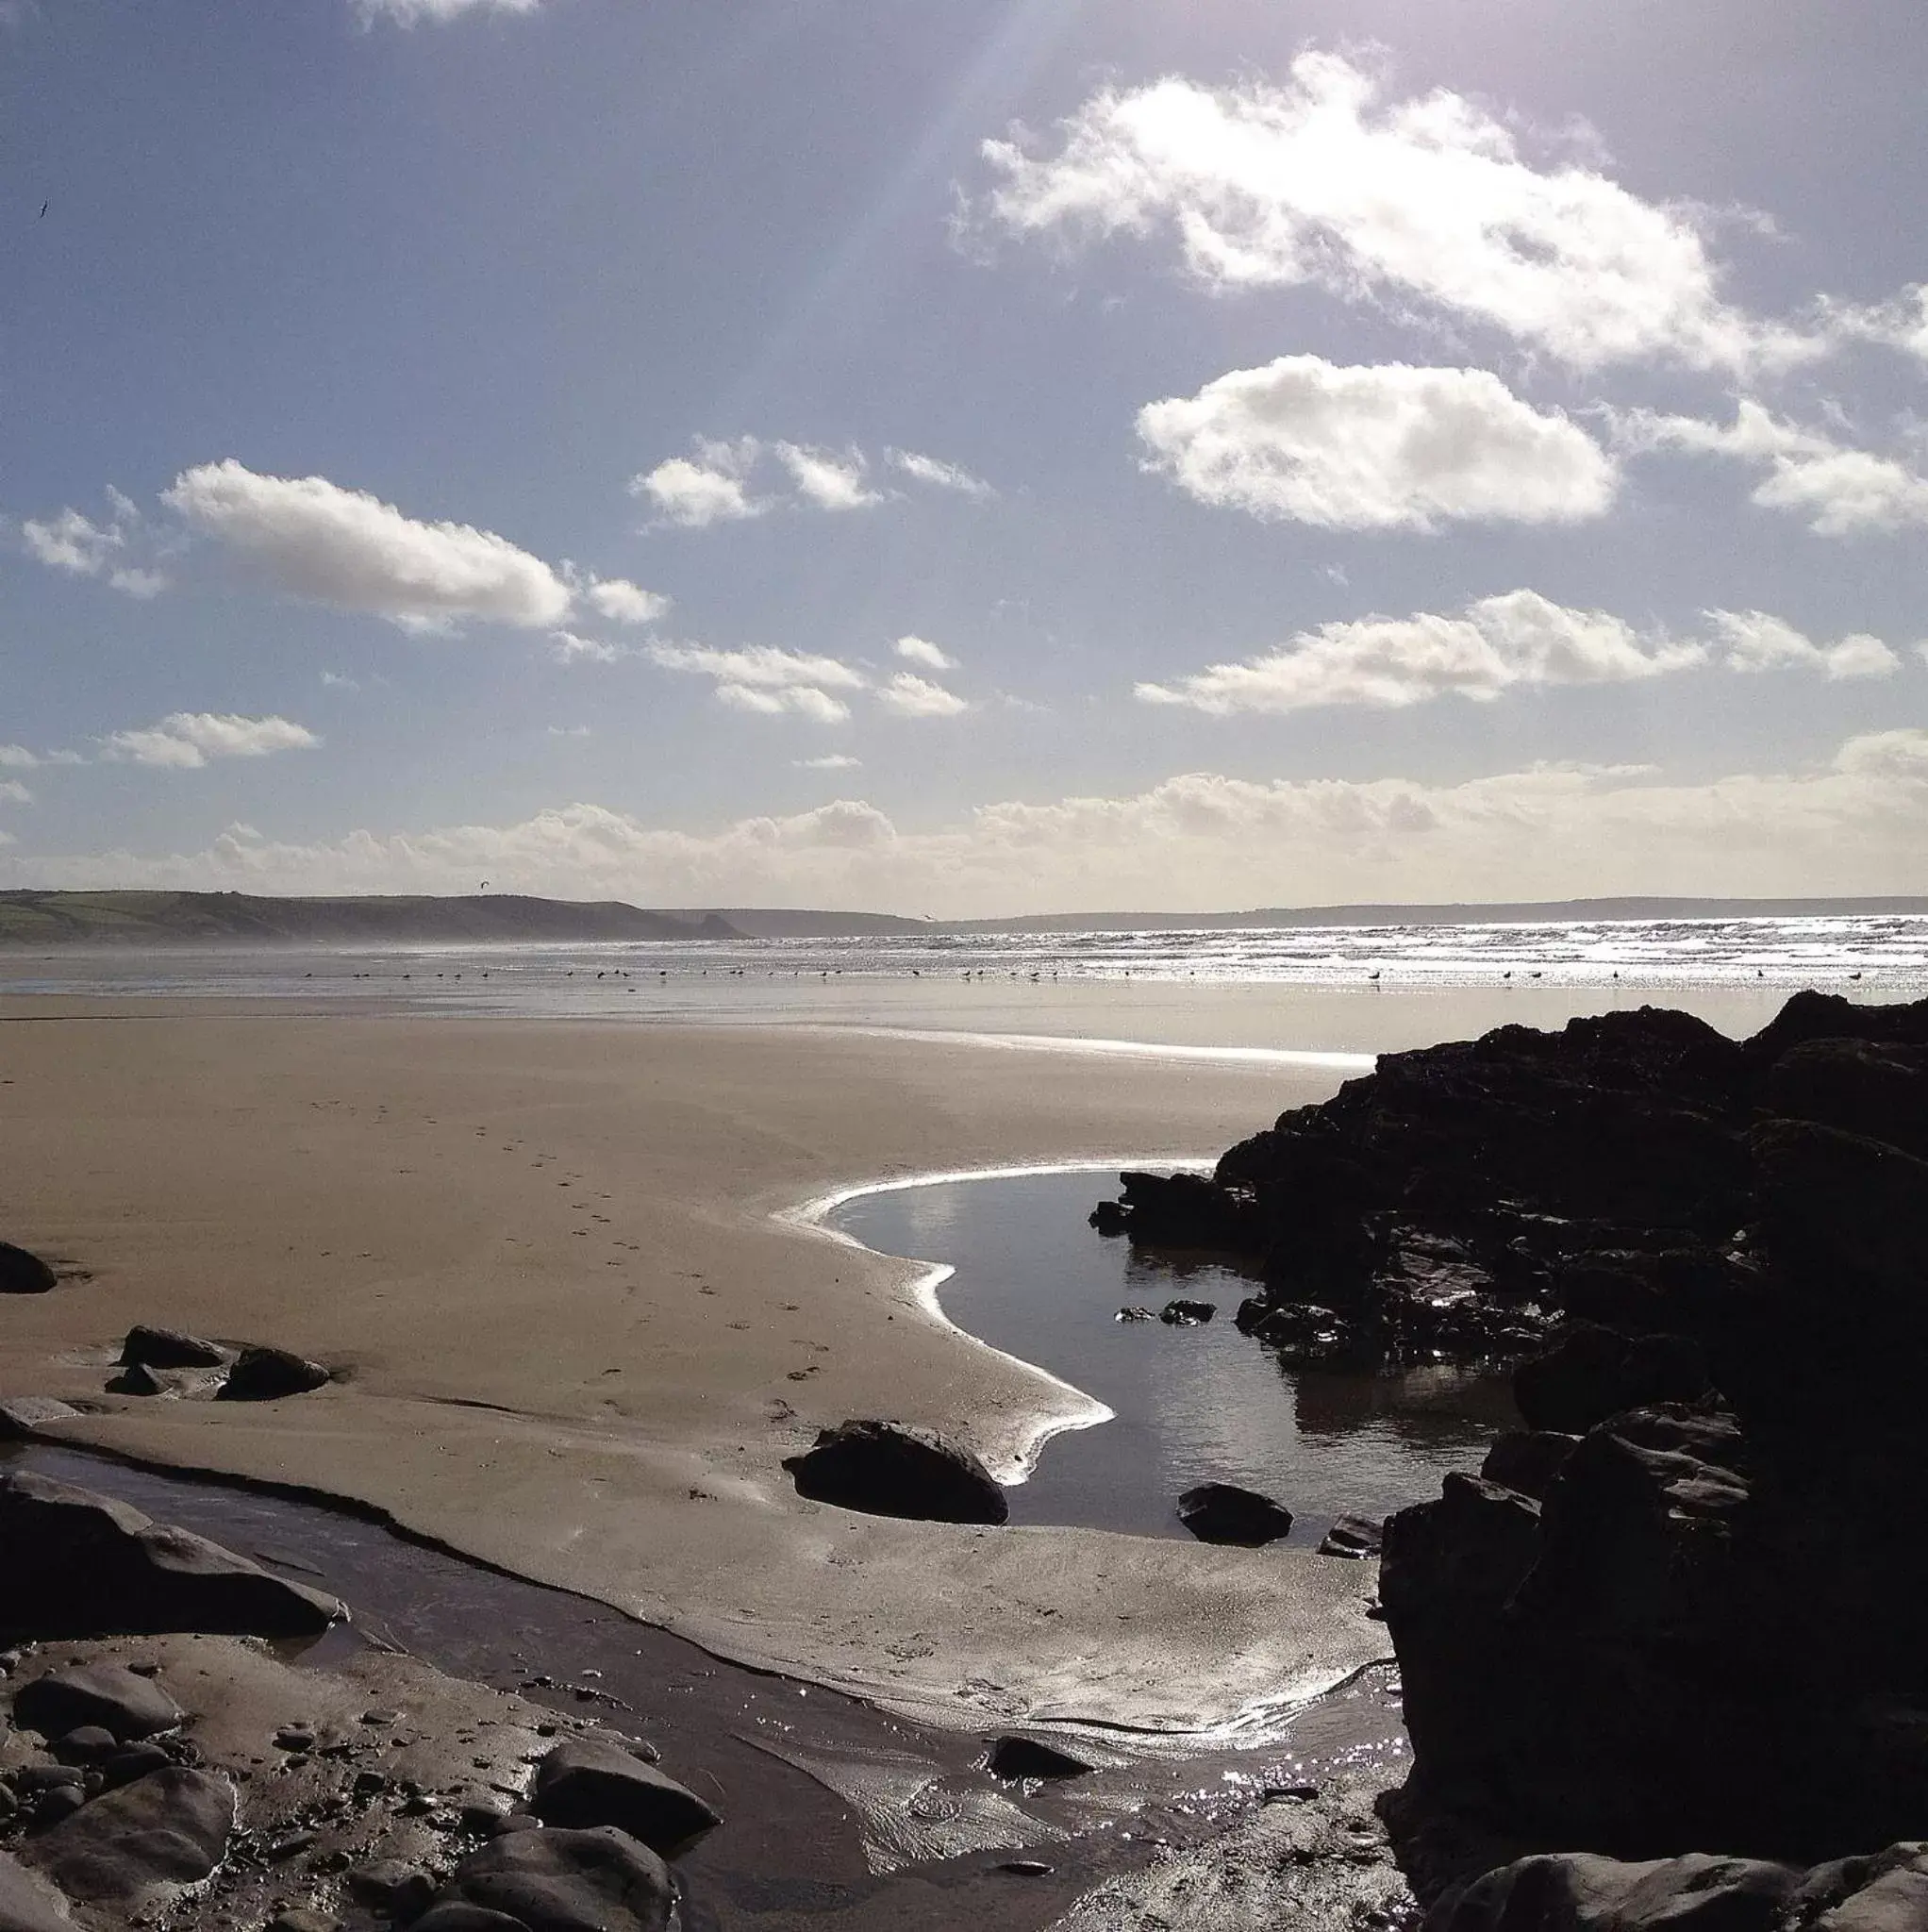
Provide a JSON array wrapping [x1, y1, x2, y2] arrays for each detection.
[[983, 52, 1820, 369]]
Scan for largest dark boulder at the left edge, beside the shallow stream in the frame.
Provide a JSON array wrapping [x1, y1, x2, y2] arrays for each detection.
[[0, 1471, 342, 1638]]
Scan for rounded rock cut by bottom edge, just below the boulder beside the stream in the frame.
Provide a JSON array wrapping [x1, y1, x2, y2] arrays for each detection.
[[430, 1825, 674, 1932]]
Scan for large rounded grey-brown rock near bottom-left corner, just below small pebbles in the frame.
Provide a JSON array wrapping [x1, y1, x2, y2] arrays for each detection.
[[37, 1766, 234, 1905]]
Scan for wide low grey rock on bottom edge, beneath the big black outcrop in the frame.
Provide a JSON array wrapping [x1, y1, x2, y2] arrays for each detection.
[[1425, 1853, 1801, 1932]]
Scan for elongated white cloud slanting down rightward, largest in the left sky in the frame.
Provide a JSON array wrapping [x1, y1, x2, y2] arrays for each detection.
[[162, 456, 572, 630]]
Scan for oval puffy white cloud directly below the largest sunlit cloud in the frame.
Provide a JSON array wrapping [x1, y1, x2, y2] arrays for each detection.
[[1138, 356, 1619, 529]]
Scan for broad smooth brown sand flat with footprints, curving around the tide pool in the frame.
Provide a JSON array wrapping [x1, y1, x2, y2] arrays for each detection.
[[0, 1001, 1385, 1729]]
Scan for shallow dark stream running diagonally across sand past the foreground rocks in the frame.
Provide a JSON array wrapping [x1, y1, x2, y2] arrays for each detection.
[[0, 1449, 1406, 1932]]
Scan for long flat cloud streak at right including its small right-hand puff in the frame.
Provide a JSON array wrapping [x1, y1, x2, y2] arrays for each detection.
[[1136, 591, 1901, 717]]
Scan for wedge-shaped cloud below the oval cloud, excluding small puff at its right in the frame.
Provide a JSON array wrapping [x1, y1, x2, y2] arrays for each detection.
[[1136, 591, 1705, 717]]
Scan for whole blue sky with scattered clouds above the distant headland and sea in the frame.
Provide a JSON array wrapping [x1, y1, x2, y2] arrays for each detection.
[[0, 0, 1928, 916]]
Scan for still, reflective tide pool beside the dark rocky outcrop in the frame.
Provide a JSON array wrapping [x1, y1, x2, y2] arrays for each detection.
[[829, 1171, 1513, 1543]]
